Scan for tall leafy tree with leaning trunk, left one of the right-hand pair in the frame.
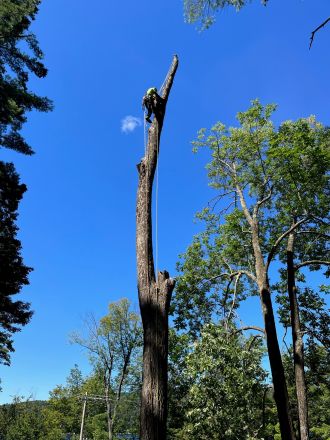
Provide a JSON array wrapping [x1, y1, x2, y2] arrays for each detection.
[[175, 101, 329, 439]]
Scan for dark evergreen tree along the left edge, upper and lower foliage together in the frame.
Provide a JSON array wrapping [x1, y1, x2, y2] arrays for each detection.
[[0, 0, 51, 365]]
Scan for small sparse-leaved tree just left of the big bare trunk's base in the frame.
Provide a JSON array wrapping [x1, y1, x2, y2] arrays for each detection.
[[71, 299, 142, 440]]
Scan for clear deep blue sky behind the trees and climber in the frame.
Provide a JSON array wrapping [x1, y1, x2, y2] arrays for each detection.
[[0, 0, 330, 402]]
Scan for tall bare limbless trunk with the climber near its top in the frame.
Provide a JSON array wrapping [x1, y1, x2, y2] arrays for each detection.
[[136, 55, 178, 440]]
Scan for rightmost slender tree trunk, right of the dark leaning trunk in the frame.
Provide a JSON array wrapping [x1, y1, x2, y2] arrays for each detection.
[[287, 233, 309, 440]]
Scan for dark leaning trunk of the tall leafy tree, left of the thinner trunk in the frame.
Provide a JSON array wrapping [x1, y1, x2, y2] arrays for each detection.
[[252, 223, 295, 440]]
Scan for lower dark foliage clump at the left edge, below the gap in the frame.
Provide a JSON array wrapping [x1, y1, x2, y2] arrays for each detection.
[[0, 161, 32, 365]]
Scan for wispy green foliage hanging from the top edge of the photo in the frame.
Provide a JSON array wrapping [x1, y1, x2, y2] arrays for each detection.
[[184, 0, 268, 30]]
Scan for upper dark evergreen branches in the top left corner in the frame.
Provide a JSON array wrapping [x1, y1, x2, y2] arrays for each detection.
[[0, 0, 52, 154]]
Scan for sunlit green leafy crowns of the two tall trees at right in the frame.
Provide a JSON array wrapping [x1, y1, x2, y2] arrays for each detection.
[[172, 100, 330, 333]]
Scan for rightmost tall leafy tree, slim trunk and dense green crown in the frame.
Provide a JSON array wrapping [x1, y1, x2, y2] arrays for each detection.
[[269, 117, 330, 440]]
